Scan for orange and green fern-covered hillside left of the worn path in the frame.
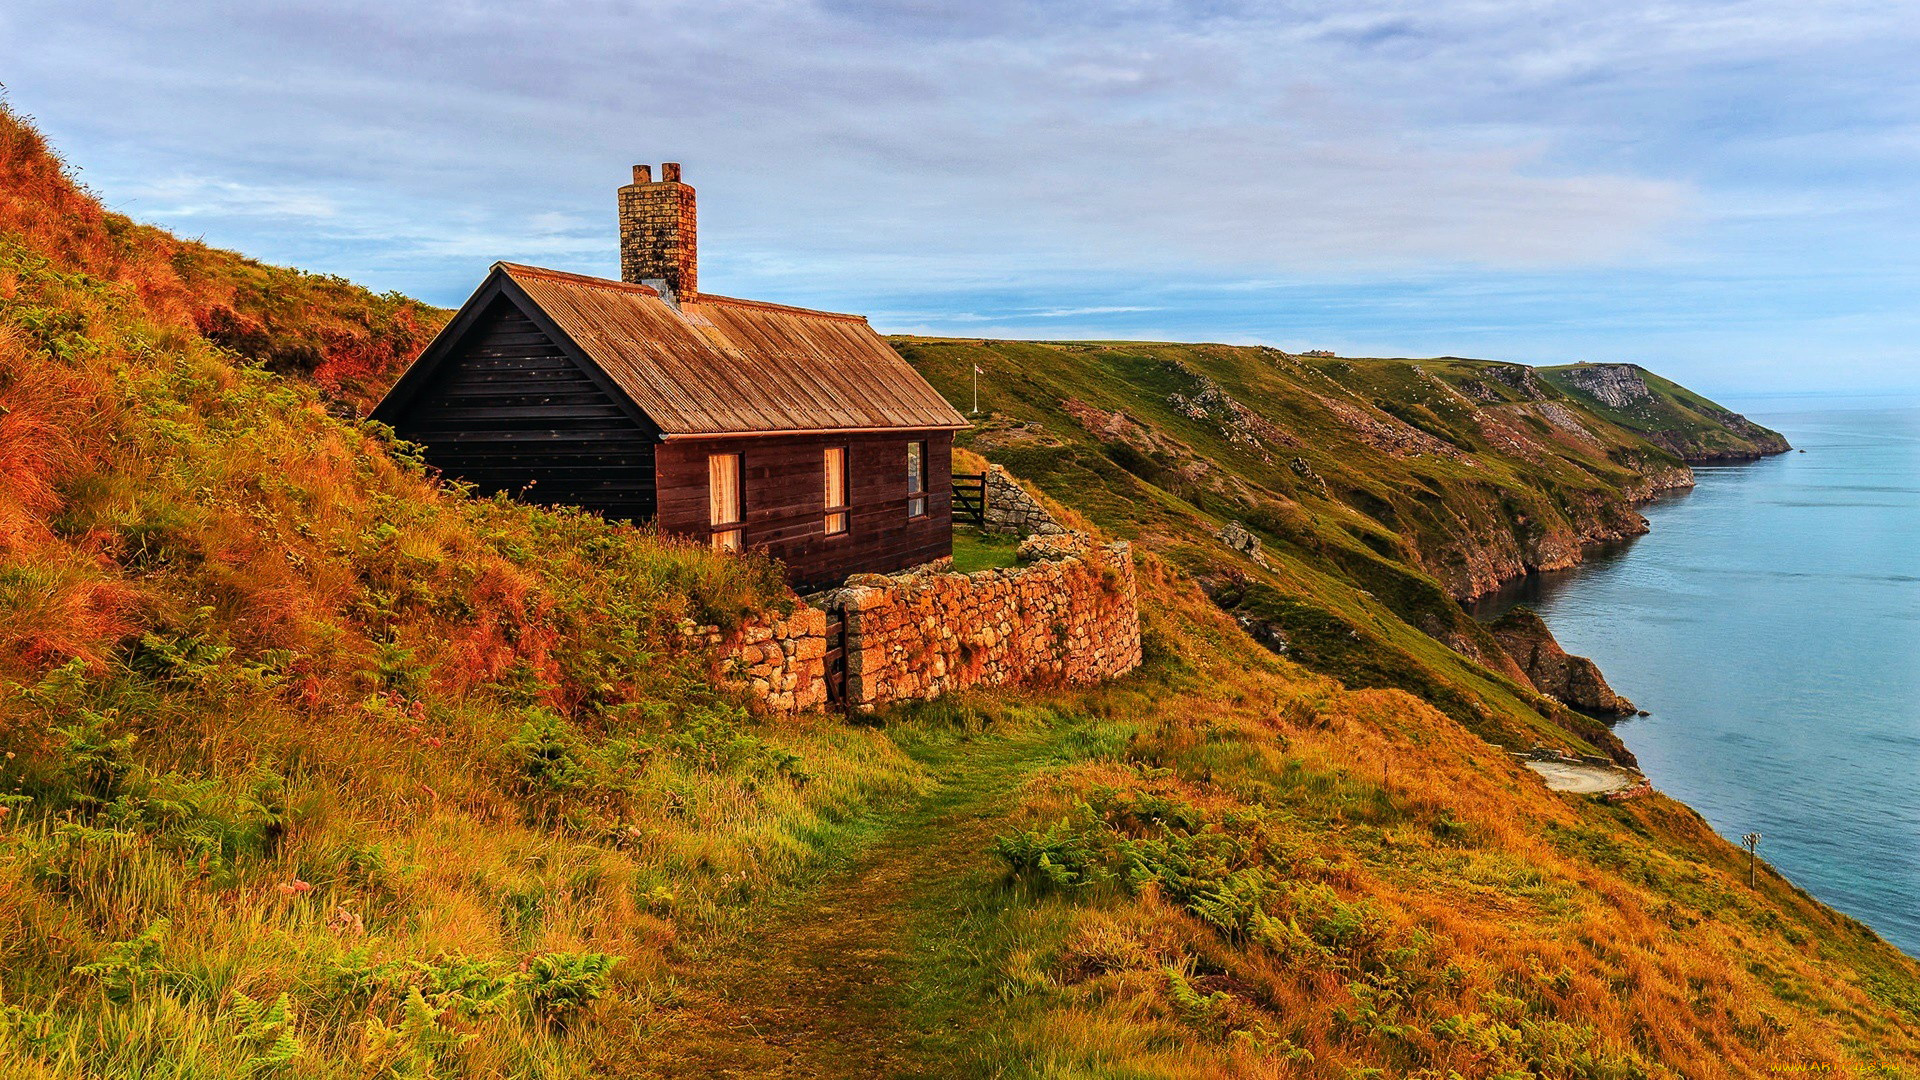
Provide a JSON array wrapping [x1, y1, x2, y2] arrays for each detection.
[[0, 105, 924, 1078]]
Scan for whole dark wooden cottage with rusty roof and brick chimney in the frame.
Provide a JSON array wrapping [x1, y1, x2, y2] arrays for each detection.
[[372, 163, 968, 588]]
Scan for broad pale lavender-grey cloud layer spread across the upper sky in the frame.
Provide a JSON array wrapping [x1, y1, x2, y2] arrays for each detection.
[[0, 0, 1728, 281]]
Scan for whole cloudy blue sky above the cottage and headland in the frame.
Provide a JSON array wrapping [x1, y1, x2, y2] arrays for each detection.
[[0, 0, 1920, 394]]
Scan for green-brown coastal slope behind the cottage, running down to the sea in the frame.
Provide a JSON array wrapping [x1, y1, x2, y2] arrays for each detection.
[[897, 340, 1692, 761]]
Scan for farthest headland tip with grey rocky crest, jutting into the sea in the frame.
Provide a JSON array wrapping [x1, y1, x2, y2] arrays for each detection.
[[1540, 363, 1789, 461]]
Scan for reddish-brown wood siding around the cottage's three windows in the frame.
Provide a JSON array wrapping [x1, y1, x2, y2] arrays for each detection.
[[657, 430, 952, 588]]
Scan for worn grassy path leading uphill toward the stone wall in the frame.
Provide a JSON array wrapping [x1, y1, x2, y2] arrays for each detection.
[[625, 730, 1064, 1078]]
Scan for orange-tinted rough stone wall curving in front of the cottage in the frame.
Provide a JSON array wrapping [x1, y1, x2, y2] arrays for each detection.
[[718, 536, 1140, 713]]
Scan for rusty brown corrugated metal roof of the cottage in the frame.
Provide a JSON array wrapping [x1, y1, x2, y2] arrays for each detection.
[[495, 263, 968, 436]]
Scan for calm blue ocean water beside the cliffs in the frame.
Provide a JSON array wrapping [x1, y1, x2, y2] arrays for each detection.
[[1475, 398, 1920, 955]]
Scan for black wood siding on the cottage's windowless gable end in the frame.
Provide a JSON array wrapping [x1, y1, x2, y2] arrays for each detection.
[[394, 298, 660, 521]]
